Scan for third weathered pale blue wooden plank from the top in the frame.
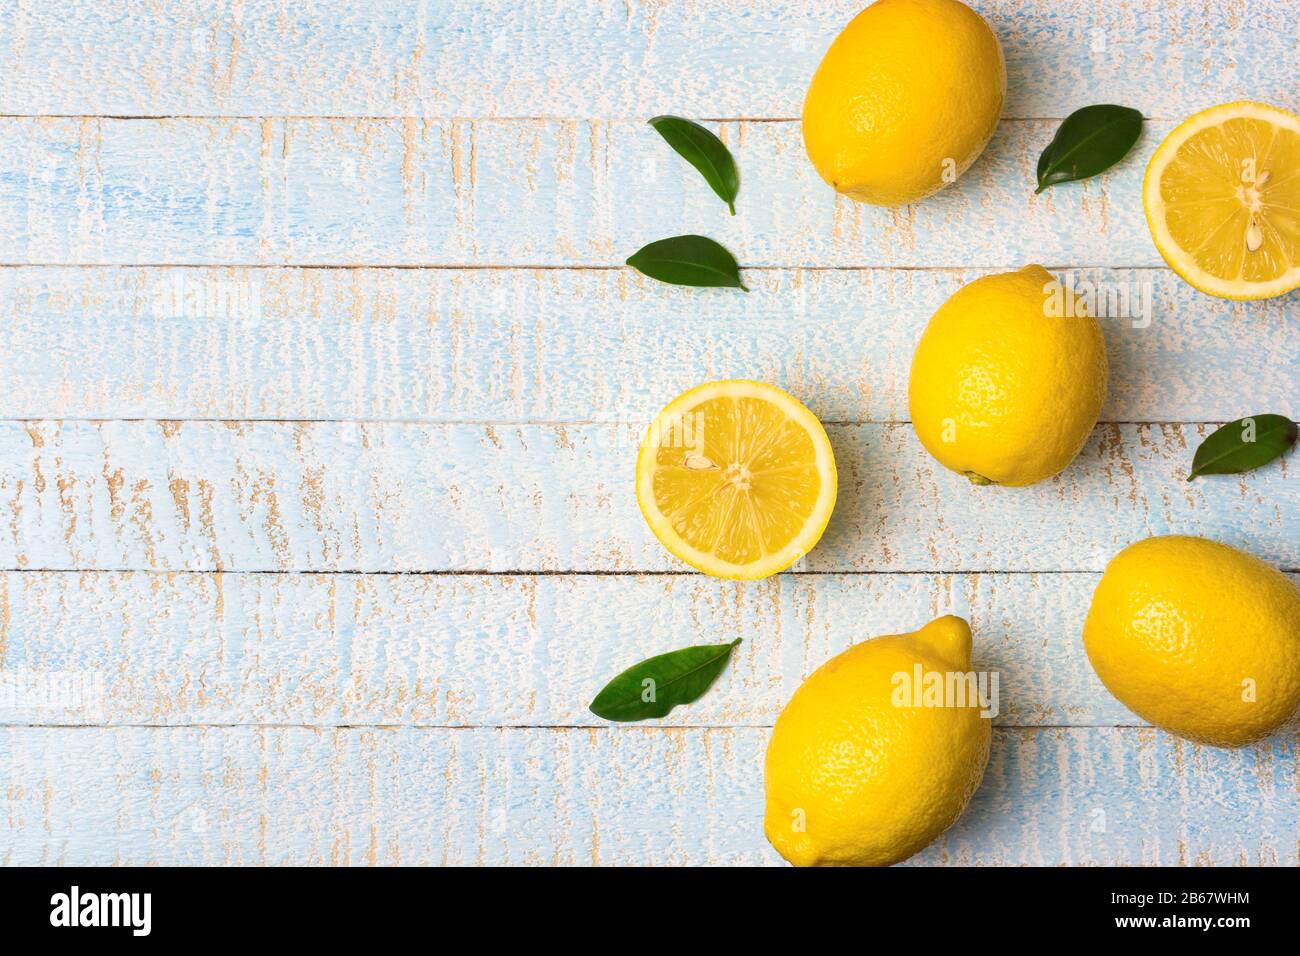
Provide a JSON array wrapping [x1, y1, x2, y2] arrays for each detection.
[[0, 267, 1300, 421]]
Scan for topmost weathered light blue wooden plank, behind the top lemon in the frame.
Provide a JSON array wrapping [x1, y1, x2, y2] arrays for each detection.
[[0, 0, 1296, 118]]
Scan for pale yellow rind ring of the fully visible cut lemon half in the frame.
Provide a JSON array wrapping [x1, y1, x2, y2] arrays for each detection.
[[636, 378, 839, 580]]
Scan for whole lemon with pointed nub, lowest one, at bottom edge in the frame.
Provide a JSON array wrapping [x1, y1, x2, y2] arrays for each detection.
[[763, 617, 992, 866]]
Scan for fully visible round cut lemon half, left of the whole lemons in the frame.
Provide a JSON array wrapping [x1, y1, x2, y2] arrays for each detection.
[[637, 380, 836, 579]]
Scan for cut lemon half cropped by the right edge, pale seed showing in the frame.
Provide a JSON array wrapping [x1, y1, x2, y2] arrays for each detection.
[[1143, 103, 1300, 299]]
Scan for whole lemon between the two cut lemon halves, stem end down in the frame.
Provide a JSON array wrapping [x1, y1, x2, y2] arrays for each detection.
[[907, 265, 1106, 485]]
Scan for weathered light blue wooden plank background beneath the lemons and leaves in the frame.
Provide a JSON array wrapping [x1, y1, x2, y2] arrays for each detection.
[[0, 0, 1300, 865]]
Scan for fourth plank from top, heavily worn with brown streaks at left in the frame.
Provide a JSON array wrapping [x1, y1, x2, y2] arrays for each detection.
[[0, 421, 1300, 571]]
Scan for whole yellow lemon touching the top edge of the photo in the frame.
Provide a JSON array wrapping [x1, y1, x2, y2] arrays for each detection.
[[803, 0, 1006, 206]]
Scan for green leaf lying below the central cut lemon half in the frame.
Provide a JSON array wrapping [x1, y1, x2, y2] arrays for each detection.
[[592, 639, 740, 721]]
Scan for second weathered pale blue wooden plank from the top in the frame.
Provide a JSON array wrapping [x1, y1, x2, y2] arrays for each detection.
[[0, 118, 1170, 267]]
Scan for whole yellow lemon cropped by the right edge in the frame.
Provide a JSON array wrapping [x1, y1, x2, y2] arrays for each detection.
[[1083, 535, 1300, 747]]
